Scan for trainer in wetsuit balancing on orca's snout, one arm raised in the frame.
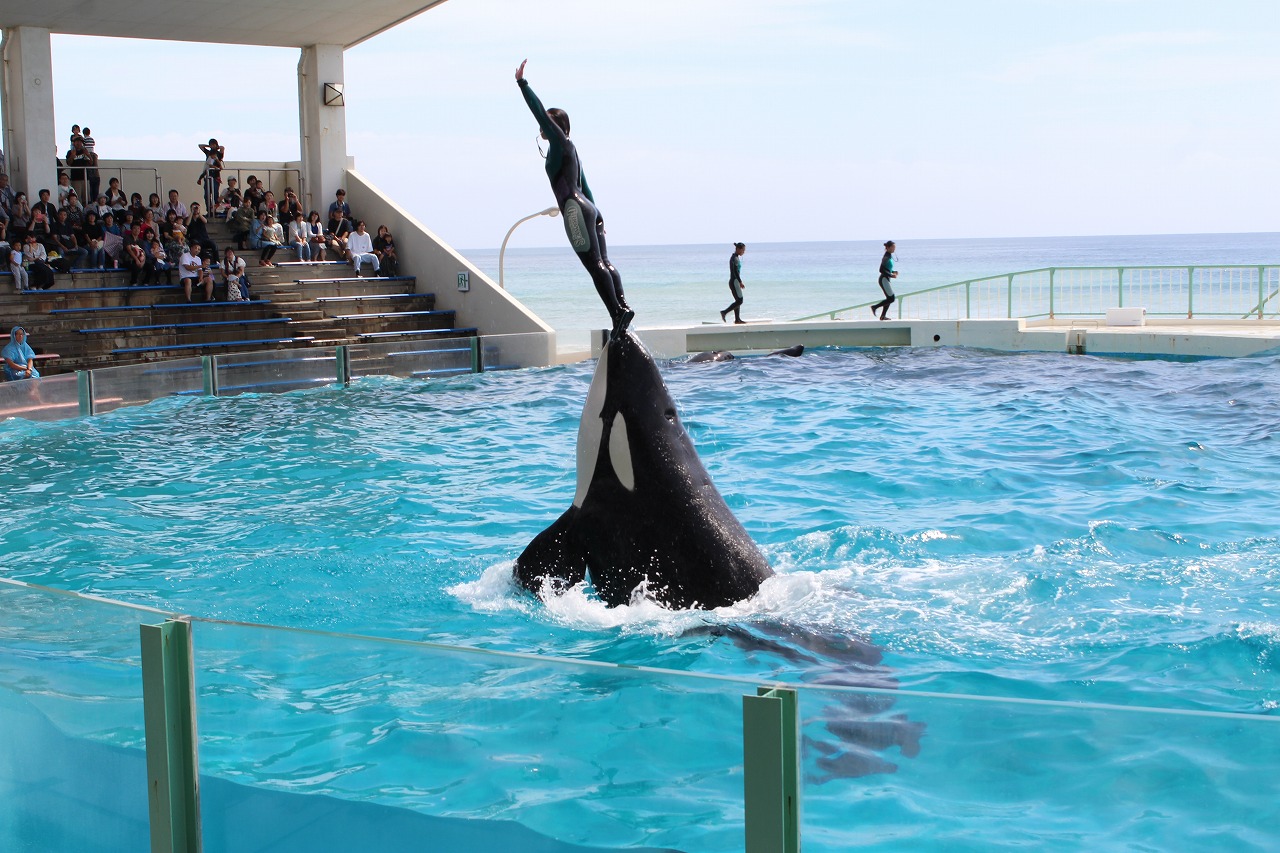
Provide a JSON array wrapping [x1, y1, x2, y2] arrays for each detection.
[[516, 59, 635, 337]]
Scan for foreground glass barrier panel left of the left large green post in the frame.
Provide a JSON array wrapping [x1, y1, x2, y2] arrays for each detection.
[[0, 580, 165, 853]]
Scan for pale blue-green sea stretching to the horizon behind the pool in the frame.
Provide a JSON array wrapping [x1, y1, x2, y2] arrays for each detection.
[[466, 233, 1280, 348]]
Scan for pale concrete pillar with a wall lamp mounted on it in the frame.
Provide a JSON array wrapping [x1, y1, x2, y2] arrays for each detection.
[[298, 45, 347, 215]]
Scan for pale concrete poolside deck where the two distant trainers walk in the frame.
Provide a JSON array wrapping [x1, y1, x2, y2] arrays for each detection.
[[606, 318, 1280, 359]]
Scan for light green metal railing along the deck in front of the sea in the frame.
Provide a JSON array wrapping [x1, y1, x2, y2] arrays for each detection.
[[796, 264, 1280, 321]]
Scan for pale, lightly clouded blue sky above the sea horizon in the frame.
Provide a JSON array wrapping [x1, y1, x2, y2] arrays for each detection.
[[20, 0, 1280, 248]]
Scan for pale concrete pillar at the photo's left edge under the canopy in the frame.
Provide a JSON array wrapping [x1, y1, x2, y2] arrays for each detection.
[[0, 27, 58, 204]]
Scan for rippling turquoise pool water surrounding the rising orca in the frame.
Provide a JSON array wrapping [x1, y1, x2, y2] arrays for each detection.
[[0, 350, 1280, 850]]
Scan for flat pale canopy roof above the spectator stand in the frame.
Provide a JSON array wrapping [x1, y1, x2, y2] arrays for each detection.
[[0, 0, 444, 47]]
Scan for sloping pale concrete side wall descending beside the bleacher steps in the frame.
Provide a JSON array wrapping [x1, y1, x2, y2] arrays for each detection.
[[345, 170, 556, 365]]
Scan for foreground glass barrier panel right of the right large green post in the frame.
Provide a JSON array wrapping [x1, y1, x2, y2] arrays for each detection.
[[800, 688, 1280, 853]]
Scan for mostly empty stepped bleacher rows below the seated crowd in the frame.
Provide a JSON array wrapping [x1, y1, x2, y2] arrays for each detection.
[[0, 210, 476, 375]]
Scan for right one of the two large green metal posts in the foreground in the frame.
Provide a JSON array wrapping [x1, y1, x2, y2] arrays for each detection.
[[742, 688, 800, 853]]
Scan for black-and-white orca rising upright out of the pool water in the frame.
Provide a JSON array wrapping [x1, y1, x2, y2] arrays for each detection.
[[515, 332, 773, 608]]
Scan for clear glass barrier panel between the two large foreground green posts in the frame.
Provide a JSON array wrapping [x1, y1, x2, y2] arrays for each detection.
[[193, 621, 755, 853]]
